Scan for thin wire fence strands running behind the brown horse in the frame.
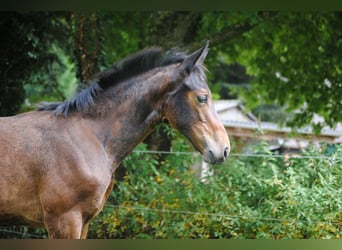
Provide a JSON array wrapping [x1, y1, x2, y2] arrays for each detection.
[[0, 150, 342, 238]]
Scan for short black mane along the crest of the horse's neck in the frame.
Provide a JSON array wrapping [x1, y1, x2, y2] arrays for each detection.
[[37, 47, 186, 117]]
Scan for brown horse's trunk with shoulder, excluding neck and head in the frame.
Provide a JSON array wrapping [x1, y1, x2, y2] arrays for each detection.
[[0, 112, 113, 238]]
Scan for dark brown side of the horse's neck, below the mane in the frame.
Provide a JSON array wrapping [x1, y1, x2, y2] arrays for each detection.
[[87, 73, 169, 167]]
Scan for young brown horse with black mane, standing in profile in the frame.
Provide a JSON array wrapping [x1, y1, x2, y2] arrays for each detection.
[[0, 44, 229, 238]]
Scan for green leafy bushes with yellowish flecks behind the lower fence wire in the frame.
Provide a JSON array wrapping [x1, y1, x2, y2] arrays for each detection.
[[89, 142, 342, 239]]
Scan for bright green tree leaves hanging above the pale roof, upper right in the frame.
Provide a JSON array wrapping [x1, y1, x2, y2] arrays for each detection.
[[225, 12, 342, 130]]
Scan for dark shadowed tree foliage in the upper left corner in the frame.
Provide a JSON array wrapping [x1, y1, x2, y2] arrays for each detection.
[[0, 12, 71, 116]]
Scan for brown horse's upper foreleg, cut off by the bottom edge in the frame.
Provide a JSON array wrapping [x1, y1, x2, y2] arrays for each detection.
[[44, 211, 83, 239]]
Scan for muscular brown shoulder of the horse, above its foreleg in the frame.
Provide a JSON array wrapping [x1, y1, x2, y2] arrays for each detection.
[[35, 116, 112, 214]]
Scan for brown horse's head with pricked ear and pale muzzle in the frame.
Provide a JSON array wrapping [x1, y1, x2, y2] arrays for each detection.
[[163, 42, 230, 164]]
